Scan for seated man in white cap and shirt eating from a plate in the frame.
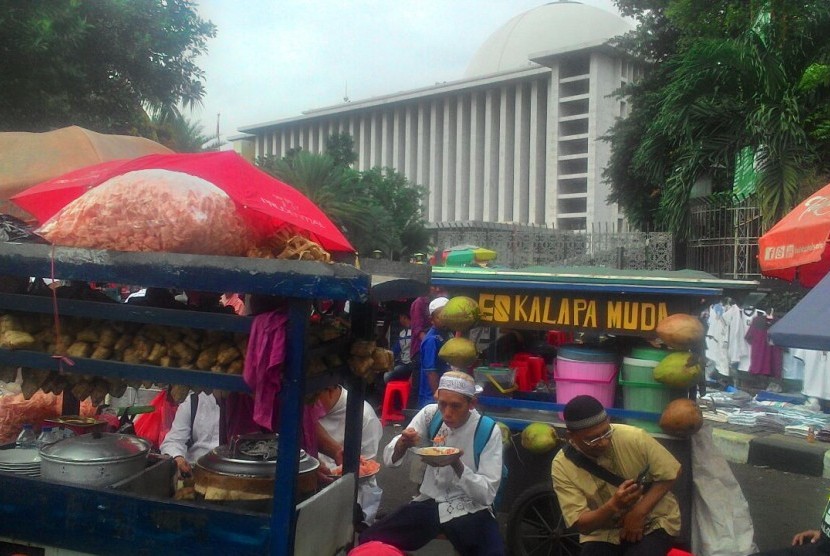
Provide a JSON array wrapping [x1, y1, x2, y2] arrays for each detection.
[[360, 371, 505, 556]]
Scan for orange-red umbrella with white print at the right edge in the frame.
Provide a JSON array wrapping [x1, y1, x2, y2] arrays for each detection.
[[758, 184, 830, 287]]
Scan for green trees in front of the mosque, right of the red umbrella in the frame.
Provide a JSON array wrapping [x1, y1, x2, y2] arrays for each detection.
[[257, 140, 429, 259]]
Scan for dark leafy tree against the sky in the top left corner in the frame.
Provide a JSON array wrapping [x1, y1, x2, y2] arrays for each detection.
[[0, 0, 215, 137]]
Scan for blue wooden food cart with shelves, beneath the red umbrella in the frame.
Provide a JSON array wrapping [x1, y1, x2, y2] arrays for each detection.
[[0, 243, 429, 556]]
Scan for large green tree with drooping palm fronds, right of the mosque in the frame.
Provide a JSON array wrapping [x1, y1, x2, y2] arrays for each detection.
[[605, 0, 830, 235]]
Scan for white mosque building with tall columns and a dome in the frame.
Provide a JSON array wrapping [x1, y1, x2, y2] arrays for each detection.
[[234, 1, 639, 231]]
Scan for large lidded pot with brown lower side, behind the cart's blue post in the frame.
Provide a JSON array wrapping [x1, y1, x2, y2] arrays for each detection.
[[193, 434, 320, 511]]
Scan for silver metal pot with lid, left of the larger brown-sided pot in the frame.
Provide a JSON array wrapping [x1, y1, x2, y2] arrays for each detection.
[[40, 432, 150, 487]]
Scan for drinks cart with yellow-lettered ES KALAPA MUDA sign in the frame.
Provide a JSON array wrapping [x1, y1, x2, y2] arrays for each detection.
[[432, 267, 757, 556]]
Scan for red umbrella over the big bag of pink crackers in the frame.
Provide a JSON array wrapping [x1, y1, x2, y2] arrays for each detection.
[[11, 151, 354, 252]]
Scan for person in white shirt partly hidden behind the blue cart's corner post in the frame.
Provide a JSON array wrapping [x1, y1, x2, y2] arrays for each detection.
[[317, 386, 383, 524]]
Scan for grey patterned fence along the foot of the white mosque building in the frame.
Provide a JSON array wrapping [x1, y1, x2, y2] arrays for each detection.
[[431, 222, 675, 270]]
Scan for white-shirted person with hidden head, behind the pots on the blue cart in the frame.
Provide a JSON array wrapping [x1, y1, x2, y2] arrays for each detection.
[[159, 392, 219, 477]]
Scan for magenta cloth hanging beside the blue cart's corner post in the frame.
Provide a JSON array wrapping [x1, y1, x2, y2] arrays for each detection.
[[242, 311, 288, 430]]
